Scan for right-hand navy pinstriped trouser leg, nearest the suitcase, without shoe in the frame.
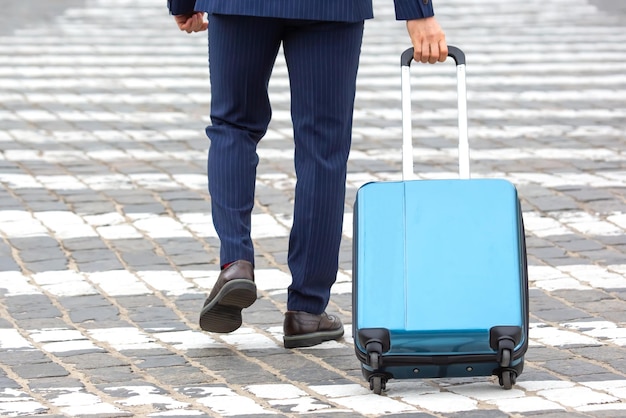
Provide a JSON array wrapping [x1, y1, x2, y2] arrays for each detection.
[[284, 22, 363, 315]]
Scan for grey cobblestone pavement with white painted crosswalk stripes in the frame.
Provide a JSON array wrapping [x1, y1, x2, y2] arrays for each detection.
[[0, 0, 626, 417]]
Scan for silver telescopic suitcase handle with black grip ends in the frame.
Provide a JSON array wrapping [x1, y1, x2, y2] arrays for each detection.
[[401, 45, 470, 180]]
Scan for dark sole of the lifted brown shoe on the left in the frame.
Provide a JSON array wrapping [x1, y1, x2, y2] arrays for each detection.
[[200, 279, 257, 333]]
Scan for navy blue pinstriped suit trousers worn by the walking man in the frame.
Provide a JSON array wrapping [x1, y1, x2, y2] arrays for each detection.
[[206, 15, 363, 314]]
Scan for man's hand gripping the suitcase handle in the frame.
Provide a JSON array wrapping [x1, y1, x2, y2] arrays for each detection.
[[406, 17, 448, 64]]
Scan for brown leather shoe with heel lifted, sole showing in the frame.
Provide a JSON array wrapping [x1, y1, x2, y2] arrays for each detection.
[[200, 260, 256, 333]]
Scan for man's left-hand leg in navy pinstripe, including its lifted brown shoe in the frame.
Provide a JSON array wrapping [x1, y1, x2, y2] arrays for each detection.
[[200, 15, 280, 332]]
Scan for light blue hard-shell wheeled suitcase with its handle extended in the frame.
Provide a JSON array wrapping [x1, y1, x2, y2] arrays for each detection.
[[353, 46, 528, 394]]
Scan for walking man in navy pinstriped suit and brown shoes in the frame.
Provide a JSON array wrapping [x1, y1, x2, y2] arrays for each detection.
[[168, 0, 447, 348]]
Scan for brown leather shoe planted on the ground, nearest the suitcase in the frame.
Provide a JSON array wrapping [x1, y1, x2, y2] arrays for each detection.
[[283, 311, 343, 348]]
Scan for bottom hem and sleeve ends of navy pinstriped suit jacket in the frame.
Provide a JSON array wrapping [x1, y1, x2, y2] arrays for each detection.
[[167, 0, 434, 22]]
